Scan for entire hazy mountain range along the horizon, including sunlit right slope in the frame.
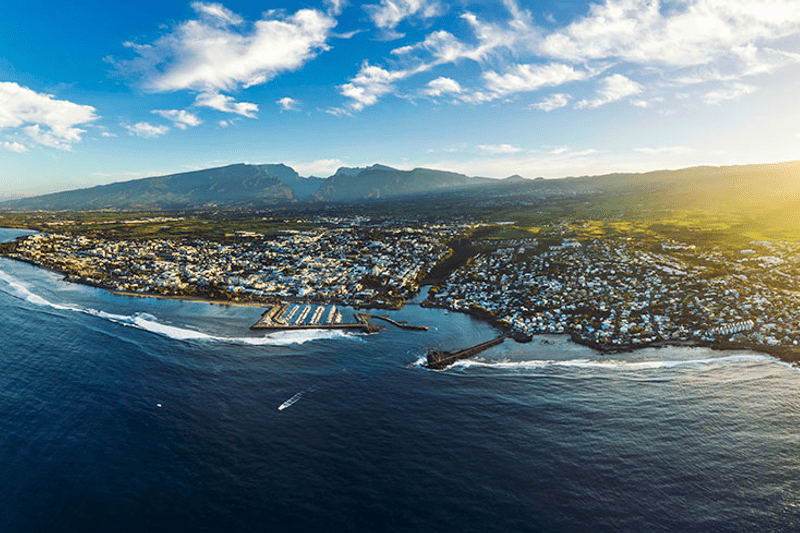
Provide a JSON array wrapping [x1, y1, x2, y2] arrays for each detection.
[[0, 161, 800, 222]]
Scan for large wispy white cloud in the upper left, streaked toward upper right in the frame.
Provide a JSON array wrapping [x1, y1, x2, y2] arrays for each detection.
[[110, 2, 334, 117]]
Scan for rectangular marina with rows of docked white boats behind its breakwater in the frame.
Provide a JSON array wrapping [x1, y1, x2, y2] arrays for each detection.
[[250, 302, 378, 333]]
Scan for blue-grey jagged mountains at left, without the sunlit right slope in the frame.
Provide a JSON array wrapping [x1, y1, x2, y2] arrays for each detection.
[[0, 164, 496, 211]]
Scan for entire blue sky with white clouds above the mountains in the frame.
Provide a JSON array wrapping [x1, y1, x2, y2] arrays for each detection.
[[0, 0, 800, 197]]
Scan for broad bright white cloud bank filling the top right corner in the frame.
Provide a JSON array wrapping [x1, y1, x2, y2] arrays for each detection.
[[539, 0, 800, 75]]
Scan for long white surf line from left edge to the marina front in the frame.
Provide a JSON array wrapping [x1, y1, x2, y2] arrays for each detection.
[[0, 270, 358, 346]]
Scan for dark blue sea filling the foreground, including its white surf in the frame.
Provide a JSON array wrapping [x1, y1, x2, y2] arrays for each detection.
[[0, 225, 800, 532]]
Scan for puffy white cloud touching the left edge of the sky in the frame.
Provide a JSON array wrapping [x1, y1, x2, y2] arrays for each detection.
[[0, 82, 99, 150]]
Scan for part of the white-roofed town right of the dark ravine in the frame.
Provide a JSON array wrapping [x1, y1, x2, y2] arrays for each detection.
[[427, 233, 800, 352]]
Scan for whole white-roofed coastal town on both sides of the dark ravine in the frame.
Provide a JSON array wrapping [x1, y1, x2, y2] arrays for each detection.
[[4, 217, 800, 357]]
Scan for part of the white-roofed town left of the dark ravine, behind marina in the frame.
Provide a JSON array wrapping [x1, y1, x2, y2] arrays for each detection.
[[4, 215, 461, 308]]
